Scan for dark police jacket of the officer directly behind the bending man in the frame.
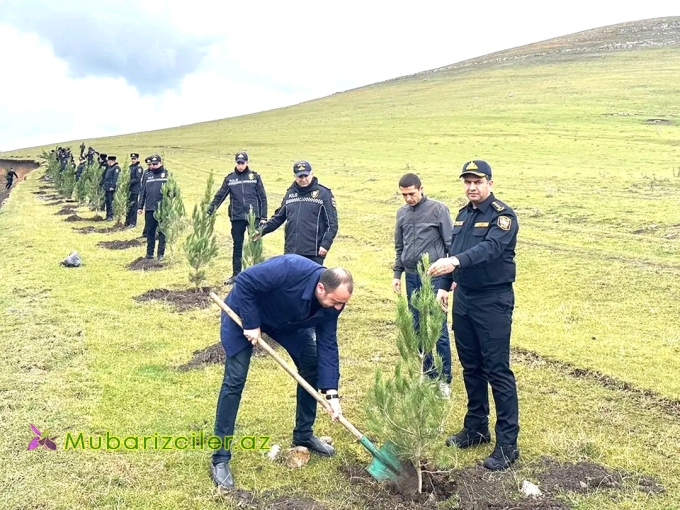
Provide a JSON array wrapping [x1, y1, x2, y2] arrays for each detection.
[[262, 177, 338, 256]]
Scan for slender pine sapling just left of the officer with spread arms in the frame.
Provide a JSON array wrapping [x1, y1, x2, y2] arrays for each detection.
[[184, 172, 217, 292]]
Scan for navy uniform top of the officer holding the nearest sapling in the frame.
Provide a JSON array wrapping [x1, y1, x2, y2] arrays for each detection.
[[440, 193, 519, 291]]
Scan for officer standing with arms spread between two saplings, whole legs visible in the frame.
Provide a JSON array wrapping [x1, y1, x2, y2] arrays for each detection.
[[208, 151, 267, 285]]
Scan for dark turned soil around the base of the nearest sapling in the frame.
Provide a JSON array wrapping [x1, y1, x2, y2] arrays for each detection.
[[339, 457, 664, 510]]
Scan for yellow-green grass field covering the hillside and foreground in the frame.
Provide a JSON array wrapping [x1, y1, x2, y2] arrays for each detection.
[[0, 17, 680, 510]]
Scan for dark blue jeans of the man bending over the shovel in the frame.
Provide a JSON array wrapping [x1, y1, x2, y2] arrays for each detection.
[[212, 329, 318, 464]]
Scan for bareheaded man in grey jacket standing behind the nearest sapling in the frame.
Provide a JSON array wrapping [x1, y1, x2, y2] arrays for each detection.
[[392, 173, 453, 398]]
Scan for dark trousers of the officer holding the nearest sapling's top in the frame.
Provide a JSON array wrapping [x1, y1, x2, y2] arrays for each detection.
[[453, 285, 519, 445]]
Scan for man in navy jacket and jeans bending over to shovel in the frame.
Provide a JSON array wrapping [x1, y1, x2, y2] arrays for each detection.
[[211, 254, 353, 488]]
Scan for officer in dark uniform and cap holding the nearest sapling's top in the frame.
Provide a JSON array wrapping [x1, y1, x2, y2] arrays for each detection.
[[428, 160, 519, 471]]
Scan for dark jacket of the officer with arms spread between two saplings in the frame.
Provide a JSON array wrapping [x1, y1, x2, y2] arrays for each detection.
[[209, 167, 267, 221]]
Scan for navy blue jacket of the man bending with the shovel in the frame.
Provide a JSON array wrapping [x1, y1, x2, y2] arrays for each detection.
[[220, 255, 342, 389]]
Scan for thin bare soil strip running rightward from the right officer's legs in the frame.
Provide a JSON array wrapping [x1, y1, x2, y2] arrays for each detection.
[[512, 347, 680, 418]]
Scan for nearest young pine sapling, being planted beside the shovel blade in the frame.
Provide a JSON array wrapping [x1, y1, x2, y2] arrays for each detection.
[[366, 254, 449, 492]]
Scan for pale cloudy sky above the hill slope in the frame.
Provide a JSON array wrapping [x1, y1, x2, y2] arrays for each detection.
[[0, 0, 680, 151]]
